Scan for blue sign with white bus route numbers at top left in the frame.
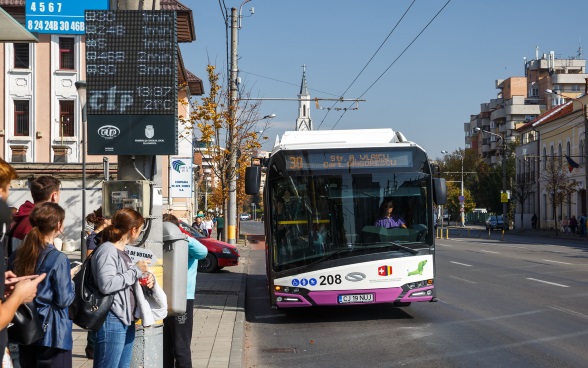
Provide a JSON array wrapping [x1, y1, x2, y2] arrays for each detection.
[[25, 0, 110, 34]]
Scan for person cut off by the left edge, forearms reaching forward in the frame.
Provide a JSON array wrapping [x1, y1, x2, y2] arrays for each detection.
[[0, 158, 46, 363]]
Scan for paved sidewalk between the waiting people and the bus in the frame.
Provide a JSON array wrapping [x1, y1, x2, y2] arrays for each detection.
[[66, 234, 250, 368]]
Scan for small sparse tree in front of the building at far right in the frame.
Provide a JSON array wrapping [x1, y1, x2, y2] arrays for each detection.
[[541, 156, 579, 235]]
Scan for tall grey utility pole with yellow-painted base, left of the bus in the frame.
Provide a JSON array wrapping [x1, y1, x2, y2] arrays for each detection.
[[226, 8, 239, 244]]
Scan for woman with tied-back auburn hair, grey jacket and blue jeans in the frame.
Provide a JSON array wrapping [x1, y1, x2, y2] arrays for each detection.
[[91, 208, 154, 368]]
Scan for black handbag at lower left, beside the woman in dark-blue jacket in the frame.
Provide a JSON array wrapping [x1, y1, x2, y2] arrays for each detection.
[[8, 249, 53, 345]]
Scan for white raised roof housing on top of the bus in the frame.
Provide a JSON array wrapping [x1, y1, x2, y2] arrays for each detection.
[[273, 128, 416, 152]]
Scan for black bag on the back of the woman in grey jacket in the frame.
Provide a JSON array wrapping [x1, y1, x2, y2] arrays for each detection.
[[69, 248, 114, 331]]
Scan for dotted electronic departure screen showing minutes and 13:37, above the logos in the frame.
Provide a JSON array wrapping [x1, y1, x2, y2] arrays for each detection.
[[85, 10, 178, 115]]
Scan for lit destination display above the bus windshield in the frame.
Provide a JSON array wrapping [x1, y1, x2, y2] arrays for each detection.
[[285, 151, 413, 170]]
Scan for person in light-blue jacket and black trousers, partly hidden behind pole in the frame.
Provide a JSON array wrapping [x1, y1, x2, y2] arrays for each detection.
[[163, 214, 208, 368]]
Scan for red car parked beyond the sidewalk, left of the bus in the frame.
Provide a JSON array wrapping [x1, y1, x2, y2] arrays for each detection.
[[180, 221, 239, 272]]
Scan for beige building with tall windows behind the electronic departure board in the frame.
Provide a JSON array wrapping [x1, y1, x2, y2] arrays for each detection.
[[0, 0, 203, 245]]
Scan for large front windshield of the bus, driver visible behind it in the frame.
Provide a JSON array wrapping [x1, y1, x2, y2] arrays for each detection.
[[266, 154, 434, 272]]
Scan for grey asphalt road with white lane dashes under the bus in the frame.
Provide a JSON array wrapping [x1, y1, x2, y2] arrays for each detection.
[[244, 233, 588, 367]]
